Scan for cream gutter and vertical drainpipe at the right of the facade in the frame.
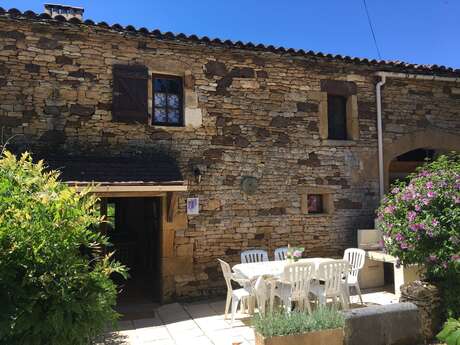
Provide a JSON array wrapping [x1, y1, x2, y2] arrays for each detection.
[[375, 72, 460, 199]]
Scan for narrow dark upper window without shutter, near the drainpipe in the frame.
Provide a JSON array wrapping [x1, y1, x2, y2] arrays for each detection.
[[327, 95, 347, 140]]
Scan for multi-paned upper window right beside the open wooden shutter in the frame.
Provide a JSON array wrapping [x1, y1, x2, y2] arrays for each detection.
[[152, 75, 183, 126]]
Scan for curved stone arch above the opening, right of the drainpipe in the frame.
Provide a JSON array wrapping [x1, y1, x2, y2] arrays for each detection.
[[383, 129, 460, 191]]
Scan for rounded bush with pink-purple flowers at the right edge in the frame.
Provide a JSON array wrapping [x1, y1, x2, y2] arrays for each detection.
[[378, 154, 460, 280]]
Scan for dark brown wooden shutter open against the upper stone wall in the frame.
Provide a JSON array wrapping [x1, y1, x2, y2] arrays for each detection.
[[112, 65, 148, 123]]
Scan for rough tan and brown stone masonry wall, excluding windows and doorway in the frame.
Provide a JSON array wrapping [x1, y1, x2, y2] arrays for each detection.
[[0, 16, 460, 297]]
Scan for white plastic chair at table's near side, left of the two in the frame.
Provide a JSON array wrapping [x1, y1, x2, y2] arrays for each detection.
[[275, 262, 315, 313]]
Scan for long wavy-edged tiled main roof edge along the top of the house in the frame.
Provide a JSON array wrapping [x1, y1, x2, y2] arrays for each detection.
[[0, 7, 460, 77]]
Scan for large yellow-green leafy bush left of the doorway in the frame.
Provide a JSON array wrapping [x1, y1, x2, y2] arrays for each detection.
[[0, 152, 126, 345]]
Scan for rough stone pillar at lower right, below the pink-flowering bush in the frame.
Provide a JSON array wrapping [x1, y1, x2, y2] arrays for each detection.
[[399, 280, 442, 341]]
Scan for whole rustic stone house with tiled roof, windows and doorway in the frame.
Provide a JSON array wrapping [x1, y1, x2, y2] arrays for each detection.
[[0, 9, 460, 301]]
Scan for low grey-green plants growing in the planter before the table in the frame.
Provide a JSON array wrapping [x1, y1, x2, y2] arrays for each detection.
[[253, 307, 345, 337]]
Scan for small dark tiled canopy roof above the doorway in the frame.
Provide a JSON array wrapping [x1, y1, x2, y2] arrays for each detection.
[[39, 154, 183, 185]]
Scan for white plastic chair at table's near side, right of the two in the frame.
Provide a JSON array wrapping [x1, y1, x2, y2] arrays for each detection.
[[310, 260, 350, 310]]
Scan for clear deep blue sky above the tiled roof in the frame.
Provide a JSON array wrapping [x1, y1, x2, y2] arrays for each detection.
[[0, 0, 460, 68]]
